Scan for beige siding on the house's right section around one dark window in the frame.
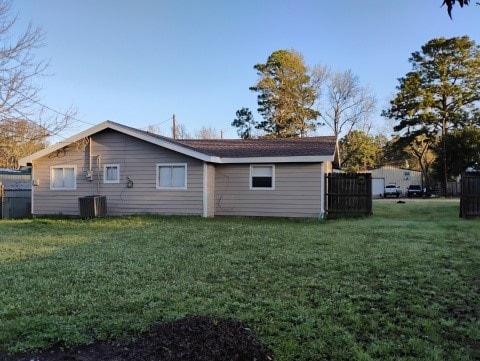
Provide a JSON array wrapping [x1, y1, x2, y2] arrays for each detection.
[[215, 163, 323, 217]]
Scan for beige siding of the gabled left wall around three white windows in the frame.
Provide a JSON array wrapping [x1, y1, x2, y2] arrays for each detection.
[[33, 130, 203, 215]]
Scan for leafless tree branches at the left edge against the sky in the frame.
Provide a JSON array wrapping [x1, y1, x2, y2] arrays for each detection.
[[0, 0, 75, 166]]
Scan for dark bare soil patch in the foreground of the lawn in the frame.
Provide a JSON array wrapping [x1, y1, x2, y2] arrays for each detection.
[[0, 317, 273, 361]]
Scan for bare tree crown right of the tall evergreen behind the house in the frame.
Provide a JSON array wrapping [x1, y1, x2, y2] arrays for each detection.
[[319, 70, 376, 139]]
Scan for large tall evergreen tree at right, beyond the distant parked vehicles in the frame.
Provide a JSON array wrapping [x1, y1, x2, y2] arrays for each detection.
[[383, 36, 480, 194]]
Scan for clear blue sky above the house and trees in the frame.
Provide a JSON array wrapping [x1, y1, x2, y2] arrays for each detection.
[[8, 0, 480, 138]]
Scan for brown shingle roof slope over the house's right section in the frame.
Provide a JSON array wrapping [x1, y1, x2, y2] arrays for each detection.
[[176, 136, 336, 158]]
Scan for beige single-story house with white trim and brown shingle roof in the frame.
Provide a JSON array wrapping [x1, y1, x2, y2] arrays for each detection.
[[20, 121, 338, 217]]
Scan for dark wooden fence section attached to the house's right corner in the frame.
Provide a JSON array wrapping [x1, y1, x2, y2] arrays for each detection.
[[325, 173, 372, 218]]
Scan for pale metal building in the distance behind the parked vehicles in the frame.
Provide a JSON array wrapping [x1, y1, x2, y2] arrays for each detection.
[[370, 165, 422, 197]]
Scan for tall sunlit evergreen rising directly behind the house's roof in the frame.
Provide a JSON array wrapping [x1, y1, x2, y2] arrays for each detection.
[[250, 50, 320, 138]]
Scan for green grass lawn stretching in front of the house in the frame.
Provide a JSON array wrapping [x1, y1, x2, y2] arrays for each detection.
[[0, 200, 480, 361]]
